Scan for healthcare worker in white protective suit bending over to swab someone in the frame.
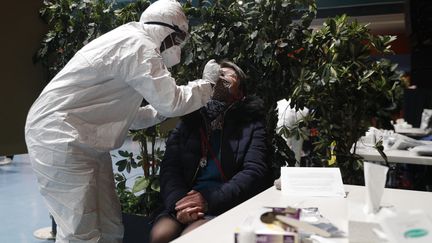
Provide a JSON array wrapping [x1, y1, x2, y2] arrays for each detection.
[[25, 0, 219, 243]]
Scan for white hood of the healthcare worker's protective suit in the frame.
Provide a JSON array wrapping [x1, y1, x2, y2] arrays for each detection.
[[140, 0, 188, 46]]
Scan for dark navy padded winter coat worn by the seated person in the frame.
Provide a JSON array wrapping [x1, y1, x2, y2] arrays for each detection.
[[160, 97, 271, 215]]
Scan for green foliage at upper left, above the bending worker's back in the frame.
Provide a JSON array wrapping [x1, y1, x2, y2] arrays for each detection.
[[33, 0, 150, 80]]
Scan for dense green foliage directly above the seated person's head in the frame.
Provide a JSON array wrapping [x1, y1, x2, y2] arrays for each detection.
[[175, 0, 316, 108]]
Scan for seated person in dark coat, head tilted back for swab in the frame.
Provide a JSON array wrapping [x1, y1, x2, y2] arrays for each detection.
[[151, 62, 272, 243]]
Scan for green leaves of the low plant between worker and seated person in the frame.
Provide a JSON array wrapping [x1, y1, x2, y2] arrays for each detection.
[[115, 126, 164, 215]]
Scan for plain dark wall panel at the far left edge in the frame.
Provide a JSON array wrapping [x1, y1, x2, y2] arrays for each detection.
[[0, 0, 46, 155]]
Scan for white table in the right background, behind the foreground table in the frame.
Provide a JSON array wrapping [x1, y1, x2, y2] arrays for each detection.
[[356, 148, 432, 165]]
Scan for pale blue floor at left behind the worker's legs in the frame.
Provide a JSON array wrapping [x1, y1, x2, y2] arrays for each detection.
[[0, 140, 147, 243]]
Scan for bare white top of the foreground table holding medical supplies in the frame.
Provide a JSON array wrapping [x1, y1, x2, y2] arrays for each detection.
[[173, 185, 432, 243]]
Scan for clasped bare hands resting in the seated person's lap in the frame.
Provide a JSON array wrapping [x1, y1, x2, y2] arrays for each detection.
[[175, 190, 207, 224]]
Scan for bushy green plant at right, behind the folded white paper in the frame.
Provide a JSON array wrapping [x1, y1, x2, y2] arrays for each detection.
[[290, 15, 402, 184]]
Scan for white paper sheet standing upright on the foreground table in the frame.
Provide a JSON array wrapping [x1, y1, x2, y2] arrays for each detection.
[[281, 167, 345, 197]]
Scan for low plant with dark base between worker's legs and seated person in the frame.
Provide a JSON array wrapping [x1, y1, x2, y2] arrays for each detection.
[[113, 126, 166, 243]]
